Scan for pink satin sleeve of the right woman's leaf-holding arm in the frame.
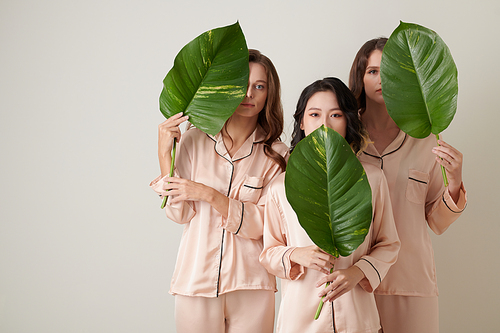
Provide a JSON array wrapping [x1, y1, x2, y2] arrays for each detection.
[[425, 157, 467, 235]]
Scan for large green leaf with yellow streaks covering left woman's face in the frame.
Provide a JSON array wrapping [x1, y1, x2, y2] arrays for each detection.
[[160, 22, 249, 135]]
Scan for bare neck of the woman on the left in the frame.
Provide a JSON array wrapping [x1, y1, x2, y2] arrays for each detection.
[[222, 113, 258, 157]]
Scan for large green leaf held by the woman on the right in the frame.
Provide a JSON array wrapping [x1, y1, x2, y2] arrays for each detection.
[[380, 22, 458, 138]]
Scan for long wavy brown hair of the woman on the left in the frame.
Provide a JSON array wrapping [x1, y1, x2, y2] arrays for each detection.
[[248, 49, 286, 171]]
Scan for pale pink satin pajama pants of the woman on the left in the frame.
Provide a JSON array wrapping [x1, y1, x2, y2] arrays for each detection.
[[175, 290, 274, 333]]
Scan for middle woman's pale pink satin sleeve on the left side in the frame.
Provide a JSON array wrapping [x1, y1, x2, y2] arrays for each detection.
[[259, 180, 305, 280]]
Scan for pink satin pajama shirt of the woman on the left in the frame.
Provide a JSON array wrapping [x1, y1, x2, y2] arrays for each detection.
[[150, 126, 288, 297]]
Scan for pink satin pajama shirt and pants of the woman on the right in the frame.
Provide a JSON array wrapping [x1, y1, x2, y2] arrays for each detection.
[[360, 131, 467, 333]]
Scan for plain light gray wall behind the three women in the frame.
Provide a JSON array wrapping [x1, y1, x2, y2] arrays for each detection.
[[0, 0, 500, 333]]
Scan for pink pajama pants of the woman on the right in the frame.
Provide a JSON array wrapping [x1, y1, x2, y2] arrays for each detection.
[[375, 295, 439, 333]]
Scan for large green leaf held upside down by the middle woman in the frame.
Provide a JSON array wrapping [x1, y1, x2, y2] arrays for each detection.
[[285, 126, 372, 257]]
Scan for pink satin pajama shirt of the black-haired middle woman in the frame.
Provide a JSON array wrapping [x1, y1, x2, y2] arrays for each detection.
[[260, 164, 399, 333]]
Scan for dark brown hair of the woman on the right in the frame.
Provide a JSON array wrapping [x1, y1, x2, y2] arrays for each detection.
[[349, 37, 387, 114]]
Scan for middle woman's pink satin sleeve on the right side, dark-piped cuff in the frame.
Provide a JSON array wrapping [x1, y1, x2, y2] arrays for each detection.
[[355, 172, 401, 293]]
